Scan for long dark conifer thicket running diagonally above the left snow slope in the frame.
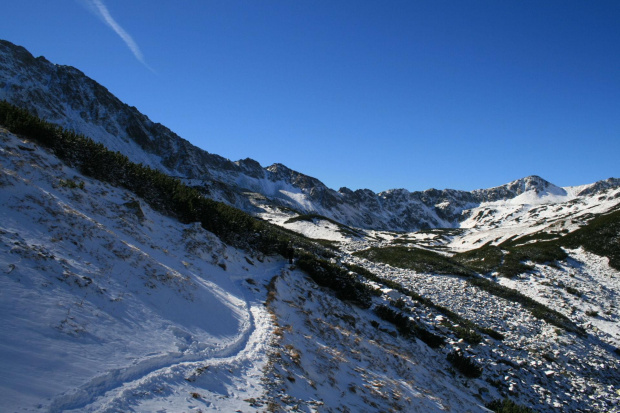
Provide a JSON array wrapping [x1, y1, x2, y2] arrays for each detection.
[[0, 101, 370, 307]]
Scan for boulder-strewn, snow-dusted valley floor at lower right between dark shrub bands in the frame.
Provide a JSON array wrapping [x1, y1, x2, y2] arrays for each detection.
[[342, 255, 620, 412]]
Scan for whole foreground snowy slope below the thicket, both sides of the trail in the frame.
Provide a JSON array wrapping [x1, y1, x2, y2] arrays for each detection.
[[0, 129, 508, 412]]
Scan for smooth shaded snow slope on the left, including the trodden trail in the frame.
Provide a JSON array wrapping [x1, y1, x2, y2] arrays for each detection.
[[0, 130, 284, 412]]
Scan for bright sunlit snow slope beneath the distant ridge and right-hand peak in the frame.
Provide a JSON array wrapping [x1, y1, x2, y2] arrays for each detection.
[[257, 177, 620, 252]]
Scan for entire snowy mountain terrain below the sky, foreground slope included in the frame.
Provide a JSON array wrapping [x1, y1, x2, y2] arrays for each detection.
[[0, 40, 620, 412]]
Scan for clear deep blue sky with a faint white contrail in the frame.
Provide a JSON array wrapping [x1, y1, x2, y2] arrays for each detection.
[[0, 0, 620, 191]]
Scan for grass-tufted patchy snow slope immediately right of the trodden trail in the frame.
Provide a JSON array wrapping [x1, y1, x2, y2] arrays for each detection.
[[262, 271, 488, 412]]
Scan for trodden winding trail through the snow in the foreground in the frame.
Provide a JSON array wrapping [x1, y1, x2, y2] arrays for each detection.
[[49, 269, 280, 413]]
